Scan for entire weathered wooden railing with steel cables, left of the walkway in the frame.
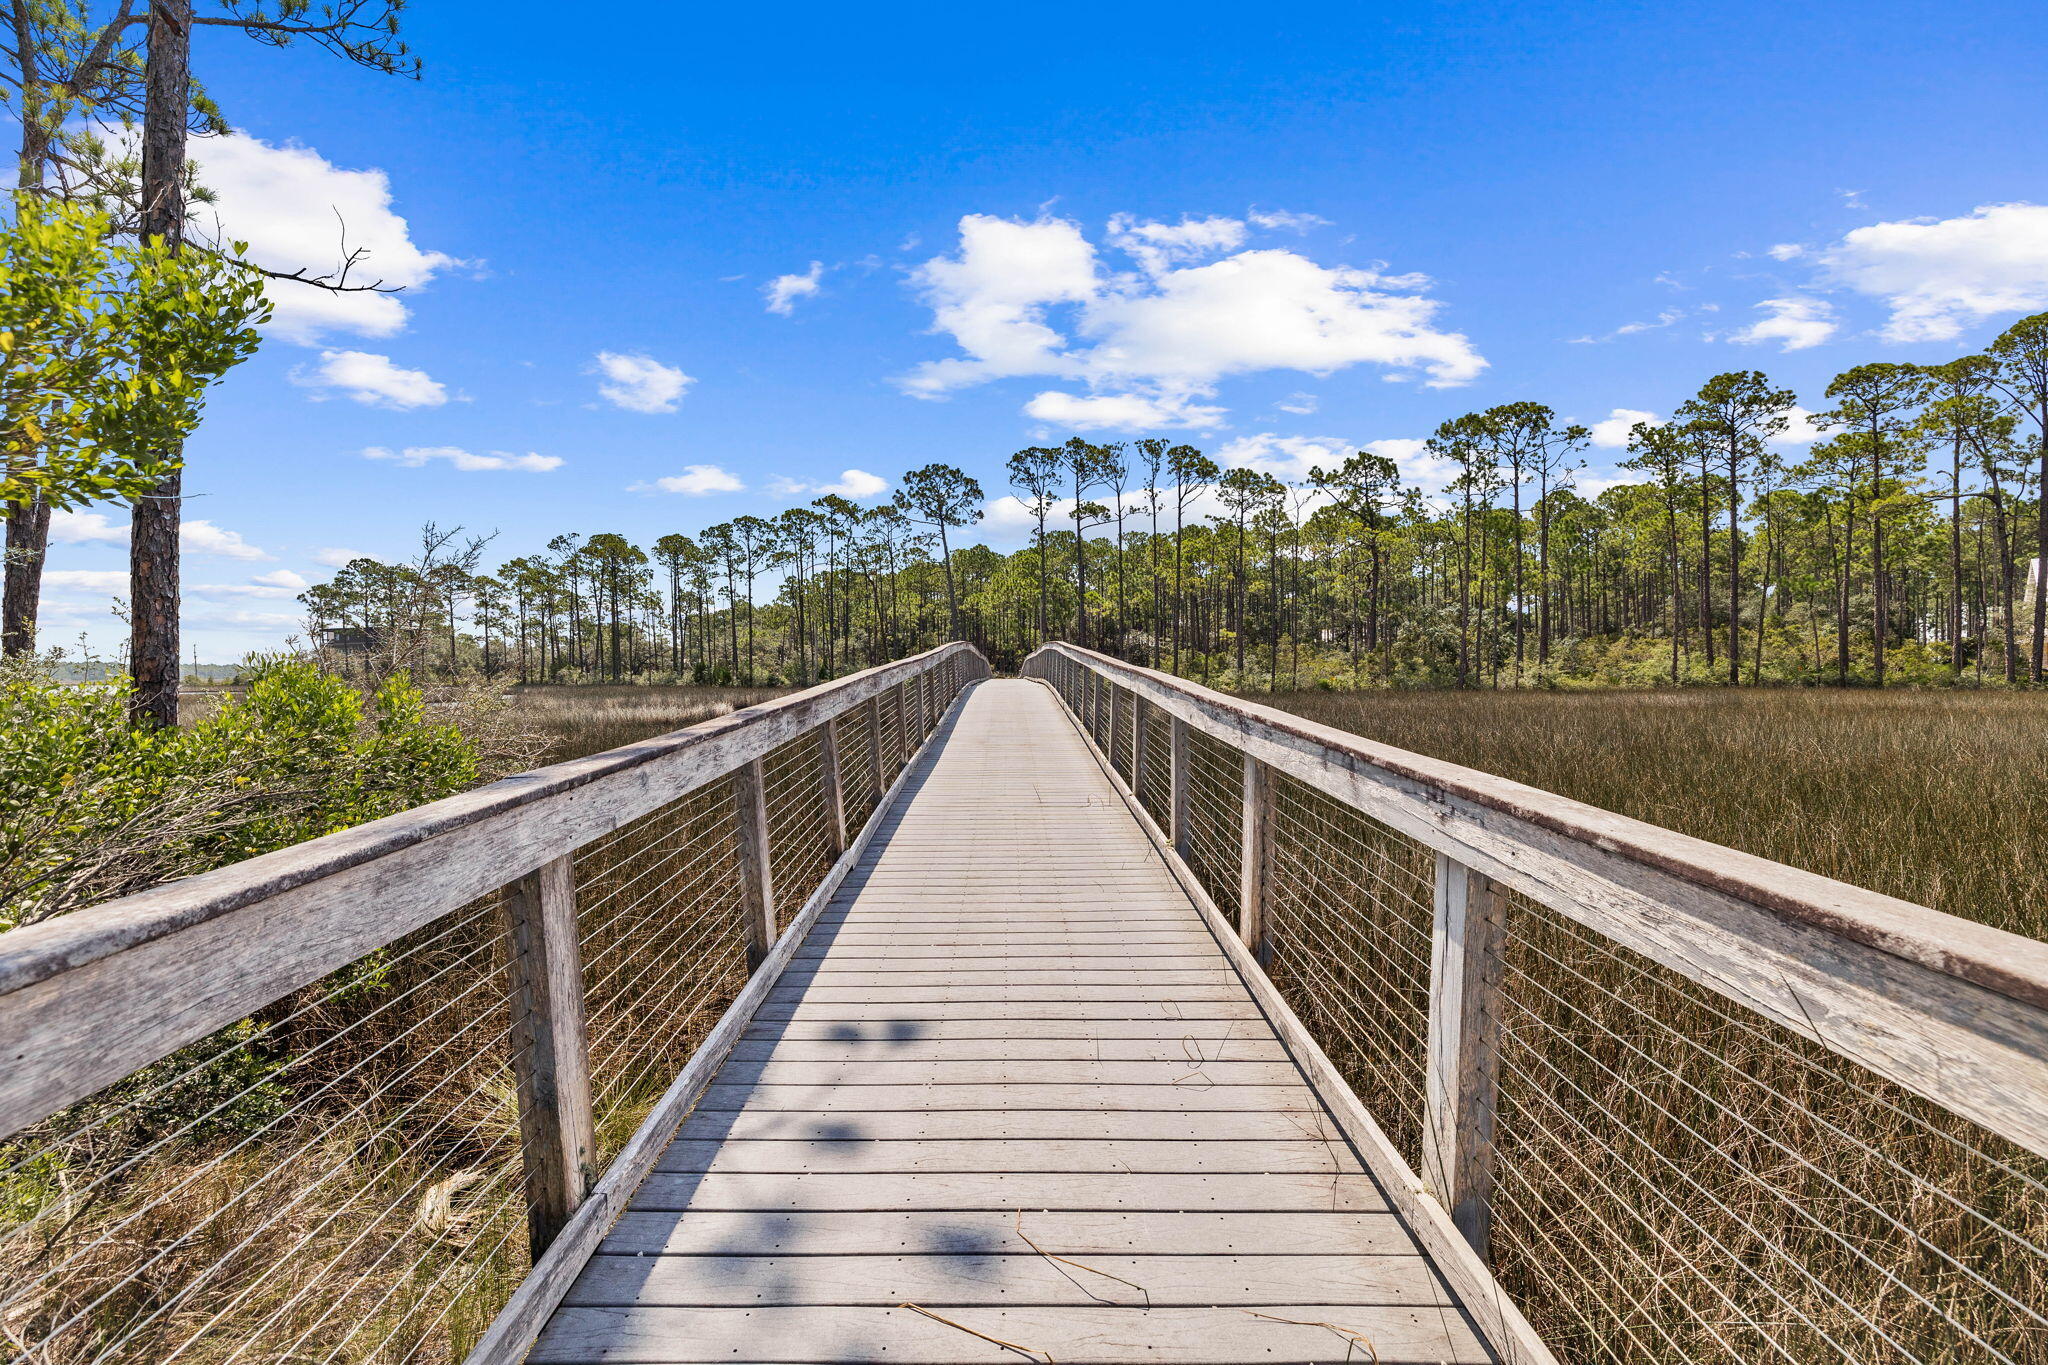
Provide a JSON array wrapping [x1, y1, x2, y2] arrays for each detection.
[[0, 645, 987, 1365]]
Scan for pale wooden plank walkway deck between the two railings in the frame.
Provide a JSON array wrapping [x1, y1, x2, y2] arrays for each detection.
[[528, 681, 1493, 1365]]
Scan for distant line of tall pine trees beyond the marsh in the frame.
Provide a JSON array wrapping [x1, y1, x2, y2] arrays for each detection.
[[303, 313, 2048, 688]]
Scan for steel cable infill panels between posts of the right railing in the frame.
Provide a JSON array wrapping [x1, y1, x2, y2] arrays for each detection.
[[1044, 657, 2048, 1365]]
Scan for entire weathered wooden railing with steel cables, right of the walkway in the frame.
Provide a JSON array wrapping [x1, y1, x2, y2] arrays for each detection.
[[1024, 645, 2048, 1365]]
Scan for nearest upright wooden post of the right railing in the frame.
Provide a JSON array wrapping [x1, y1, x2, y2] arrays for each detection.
[[1421, 853, 1507, 1259]]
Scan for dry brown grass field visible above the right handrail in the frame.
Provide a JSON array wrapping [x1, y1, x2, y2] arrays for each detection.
[[1255, 688, 2048, 937]]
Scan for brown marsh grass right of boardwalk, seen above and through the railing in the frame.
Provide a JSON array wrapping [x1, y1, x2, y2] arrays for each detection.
[[1228, 692, 2048, 1365]]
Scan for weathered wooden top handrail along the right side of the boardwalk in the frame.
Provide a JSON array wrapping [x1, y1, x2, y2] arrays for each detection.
[[1024, 643, 2048, 1154]]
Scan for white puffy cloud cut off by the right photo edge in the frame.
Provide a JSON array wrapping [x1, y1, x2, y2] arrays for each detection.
[[1818, 203, 2048, 342]]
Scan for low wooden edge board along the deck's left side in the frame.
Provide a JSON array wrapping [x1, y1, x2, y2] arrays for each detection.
[[463, 681, 977, 1365]]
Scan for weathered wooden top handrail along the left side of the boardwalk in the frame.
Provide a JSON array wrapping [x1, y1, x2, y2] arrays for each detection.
[[0, 643, 987, 1138]]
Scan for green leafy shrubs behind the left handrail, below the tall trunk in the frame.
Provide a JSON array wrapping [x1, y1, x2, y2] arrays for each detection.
[[0, 659, 477, 927]]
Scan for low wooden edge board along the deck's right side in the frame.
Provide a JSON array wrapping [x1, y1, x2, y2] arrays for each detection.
[[1036, 677, 1559, 1365]]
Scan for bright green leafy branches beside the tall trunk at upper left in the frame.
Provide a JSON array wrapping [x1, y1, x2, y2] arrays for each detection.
[[0, 199, 270, 517]]
